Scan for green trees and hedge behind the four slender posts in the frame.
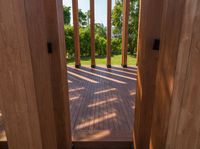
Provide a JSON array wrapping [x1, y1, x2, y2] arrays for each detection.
[[64, 0, 139, 59]]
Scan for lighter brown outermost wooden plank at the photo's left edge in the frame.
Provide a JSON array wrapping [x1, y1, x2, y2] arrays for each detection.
[[0, 0, 47, 149]]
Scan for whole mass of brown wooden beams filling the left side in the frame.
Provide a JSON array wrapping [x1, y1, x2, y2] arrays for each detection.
[[0, 0, 71, 149]]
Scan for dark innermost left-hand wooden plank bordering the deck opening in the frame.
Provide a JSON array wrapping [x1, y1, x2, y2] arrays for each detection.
[[43, 0, 71, 148]]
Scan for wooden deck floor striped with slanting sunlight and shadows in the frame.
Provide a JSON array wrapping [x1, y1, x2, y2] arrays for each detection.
[[68, 66, 136, 141]]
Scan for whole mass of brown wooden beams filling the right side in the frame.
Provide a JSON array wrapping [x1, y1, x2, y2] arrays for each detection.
[[134, 0, 200, 149]]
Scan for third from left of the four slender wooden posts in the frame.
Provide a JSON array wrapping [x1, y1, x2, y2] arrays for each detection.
[[106, 0, 112, 68]]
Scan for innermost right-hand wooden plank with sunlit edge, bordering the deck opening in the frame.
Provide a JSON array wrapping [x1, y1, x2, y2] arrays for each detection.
[[134, 0, 163, 149]]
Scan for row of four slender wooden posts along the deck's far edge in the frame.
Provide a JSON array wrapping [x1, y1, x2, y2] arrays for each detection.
[[72, 0, 130, 68]]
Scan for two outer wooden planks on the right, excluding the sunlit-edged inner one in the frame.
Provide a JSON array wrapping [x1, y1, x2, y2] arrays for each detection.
[[151, 0, 200, 149]]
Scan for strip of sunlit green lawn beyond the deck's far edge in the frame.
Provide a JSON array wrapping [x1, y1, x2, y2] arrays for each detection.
[[67, 55, 136, 66]]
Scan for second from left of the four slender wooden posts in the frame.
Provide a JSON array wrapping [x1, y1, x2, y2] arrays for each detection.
[[90, 0, 96, 68]]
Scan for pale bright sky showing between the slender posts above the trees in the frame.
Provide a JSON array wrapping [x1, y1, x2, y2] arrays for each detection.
[[63, 0, 115, 26]]
